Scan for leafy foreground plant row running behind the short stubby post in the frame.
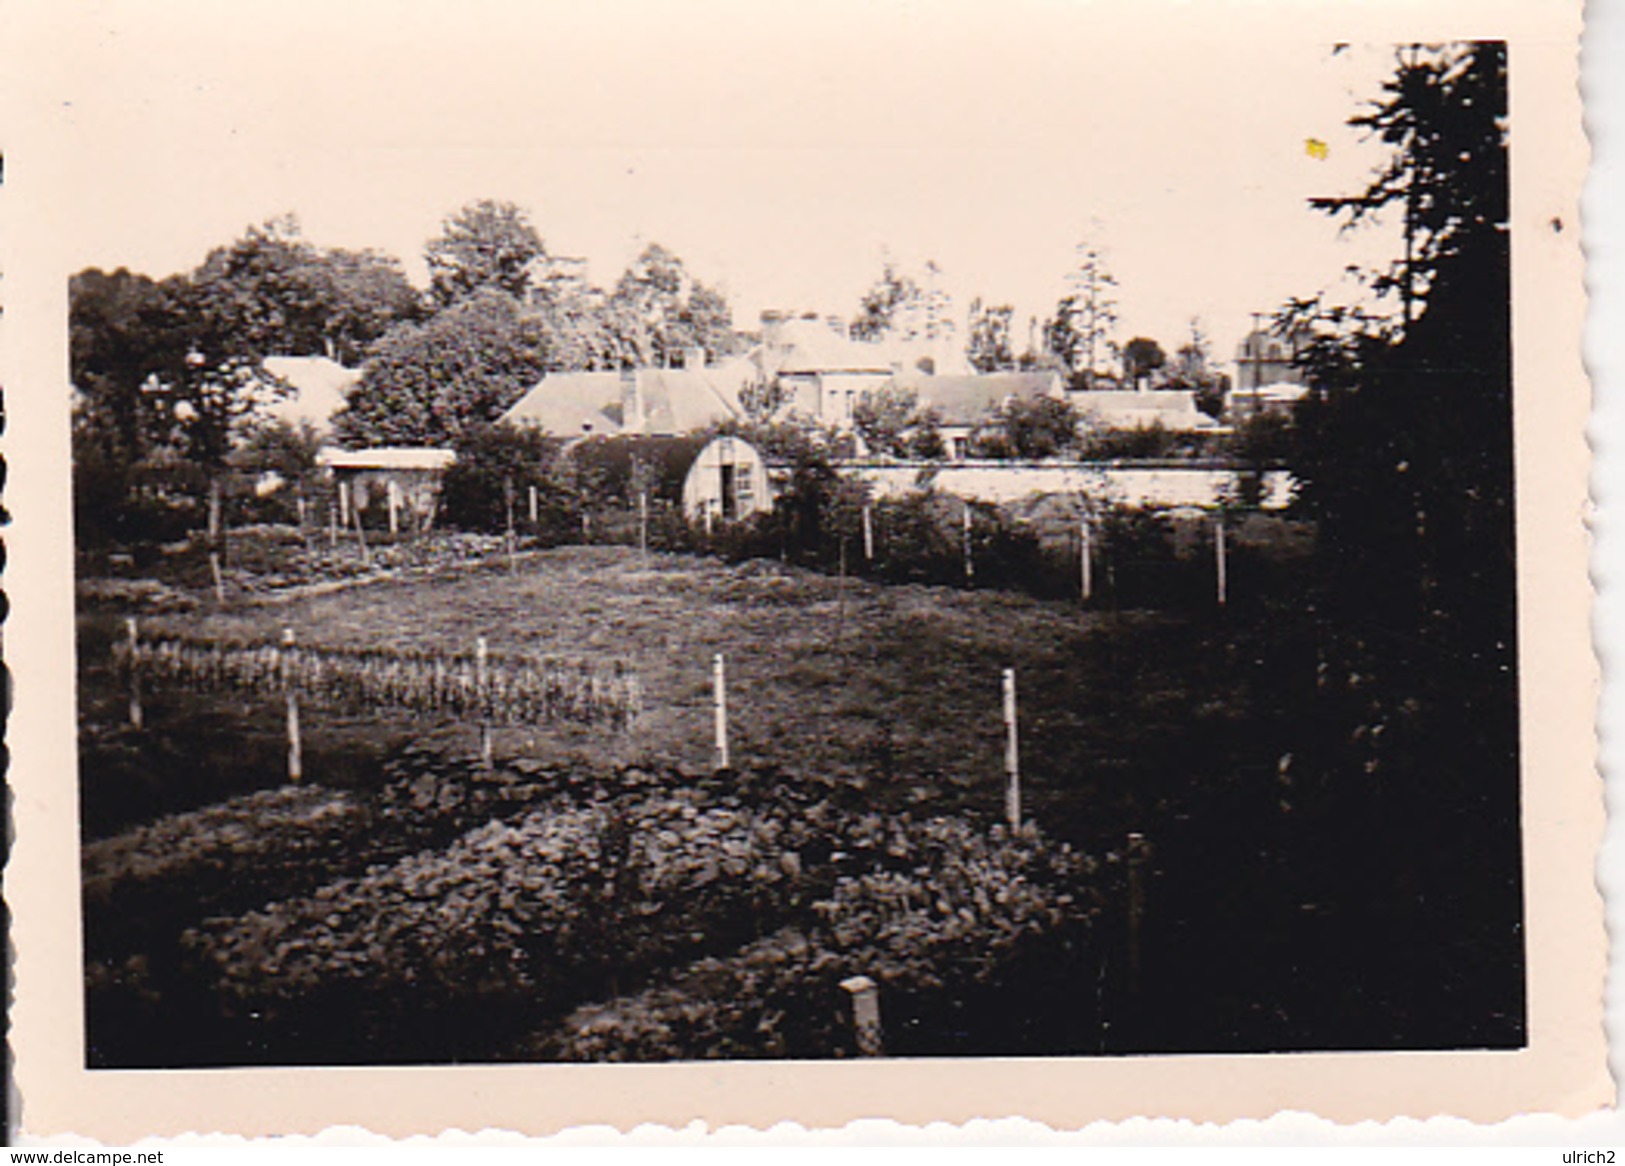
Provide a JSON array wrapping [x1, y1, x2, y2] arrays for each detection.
[[528, 818, 1102, 1062]]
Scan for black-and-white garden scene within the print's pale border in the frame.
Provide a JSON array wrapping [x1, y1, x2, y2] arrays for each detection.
[[41, 5, 1563, 1097]]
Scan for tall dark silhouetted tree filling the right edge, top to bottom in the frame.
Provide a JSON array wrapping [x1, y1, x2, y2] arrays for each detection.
[[1281, 42, 1523, 1044]]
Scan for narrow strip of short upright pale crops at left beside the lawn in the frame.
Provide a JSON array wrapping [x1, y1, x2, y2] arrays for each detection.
[[114, 637, 642, 729]]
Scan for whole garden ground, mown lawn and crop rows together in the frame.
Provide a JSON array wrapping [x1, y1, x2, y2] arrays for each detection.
[[80, 547, 1521, 1067]]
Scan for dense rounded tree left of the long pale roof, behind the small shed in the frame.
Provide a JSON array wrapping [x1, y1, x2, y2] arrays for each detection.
[[333, 287, 548, 445]]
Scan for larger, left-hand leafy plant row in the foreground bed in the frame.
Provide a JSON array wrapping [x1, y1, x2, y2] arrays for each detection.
[[184, 791, 825, 1056]]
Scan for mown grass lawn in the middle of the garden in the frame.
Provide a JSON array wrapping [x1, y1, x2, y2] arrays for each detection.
[[91, 547, 1268, 841]]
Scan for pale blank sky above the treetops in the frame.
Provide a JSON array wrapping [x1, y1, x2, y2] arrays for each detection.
[[7, 0, 1393, 359]]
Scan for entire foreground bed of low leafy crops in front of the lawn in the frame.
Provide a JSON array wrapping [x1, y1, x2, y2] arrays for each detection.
[[83, 750, 1118, 1064]]
